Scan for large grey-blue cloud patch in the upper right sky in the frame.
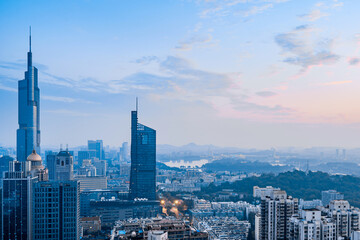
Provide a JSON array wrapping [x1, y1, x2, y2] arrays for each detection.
[[275, 25, 340, 71]]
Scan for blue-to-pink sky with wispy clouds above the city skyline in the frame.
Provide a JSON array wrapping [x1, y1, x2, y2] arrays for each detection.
[[0, 0, 360, 148]]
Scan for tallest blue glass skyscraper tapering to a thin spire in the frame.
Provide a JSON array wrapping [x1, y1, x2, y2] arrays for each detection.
[[16, 29, 40, 162]]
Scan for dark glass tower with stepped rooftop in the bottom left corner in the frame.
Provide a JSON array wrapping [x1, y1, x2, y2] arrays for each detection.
[[2, 160, 37, 240]]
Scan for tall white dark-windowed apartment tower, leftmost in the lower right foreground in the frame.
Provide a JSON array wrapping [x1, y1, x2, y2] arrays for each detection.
[[259, 190, 298, 240]]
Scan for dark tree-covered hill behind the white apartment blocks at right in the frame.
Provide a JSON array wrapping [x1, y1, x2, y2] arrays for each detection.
[[199, 171, 360, 207]]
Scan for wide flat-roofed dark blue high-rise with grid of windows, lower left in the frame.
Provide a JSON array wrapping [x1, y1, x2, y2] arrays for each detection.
[[32, 181, 80, 240]]
